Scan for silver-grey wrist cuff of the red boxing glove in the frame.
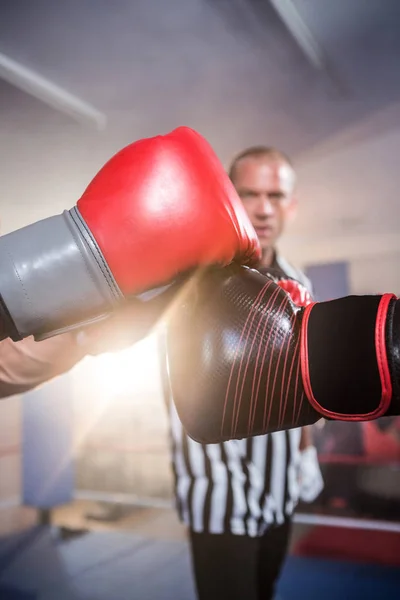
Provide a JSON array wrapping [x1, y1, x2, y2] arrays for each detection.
[[0, 207, 123, 339]]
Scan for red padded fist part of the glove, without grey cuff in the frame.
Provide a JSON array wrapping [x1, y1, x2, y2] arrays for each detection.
[[78, 127, 260, 294]]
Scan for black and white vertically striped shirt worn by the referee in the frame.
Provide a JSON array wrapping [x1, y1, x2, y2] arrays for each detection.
[[161, 257, 310, 537]]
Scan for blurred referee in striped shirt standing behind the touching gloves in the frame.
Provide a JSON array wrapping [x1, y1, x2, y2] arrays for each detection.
[[161, 146, 322, 600]]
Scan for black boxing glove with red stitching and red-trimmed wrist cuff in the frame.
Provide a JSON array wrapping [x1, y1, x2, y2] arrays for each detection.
[[167, 266, 400, 443]]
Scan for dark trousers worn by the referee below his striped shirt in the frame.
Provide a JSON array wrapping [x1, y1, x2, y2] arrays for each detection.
[[189, 522, 291, 600]]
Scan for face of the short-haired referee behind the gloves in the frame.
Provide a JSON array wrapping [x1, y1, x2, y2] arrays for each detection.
[[233, 156, 296, 250]]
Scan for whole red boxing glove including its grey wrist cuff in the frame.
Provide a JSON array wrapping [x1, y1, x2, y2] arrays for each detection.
[[0, 127, 261, 340]]
